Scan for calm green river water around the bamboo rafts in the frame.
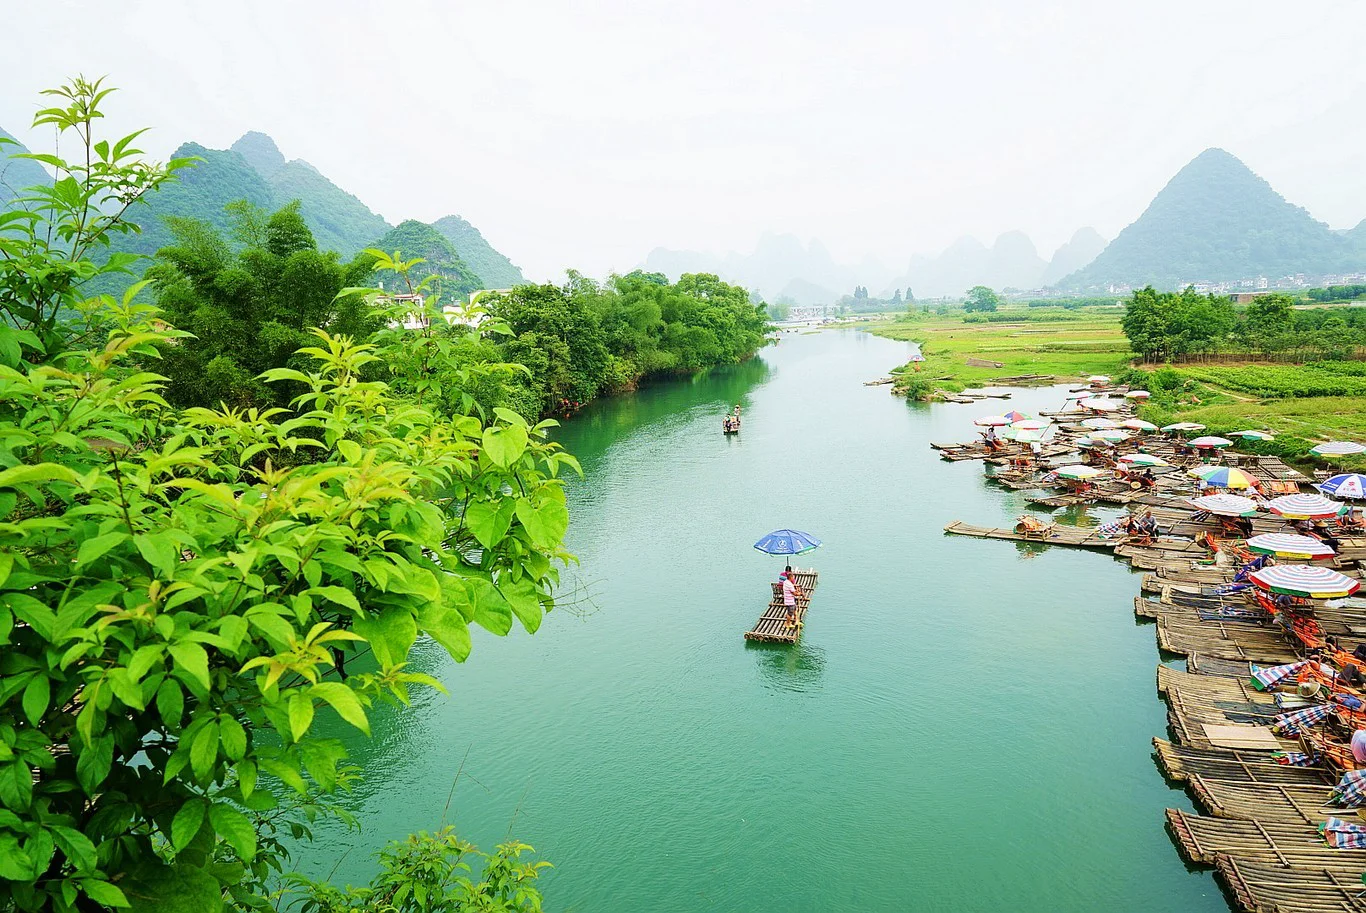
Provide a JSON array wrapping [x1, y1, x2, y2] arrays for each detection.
[[316, 331, 1227, 913]]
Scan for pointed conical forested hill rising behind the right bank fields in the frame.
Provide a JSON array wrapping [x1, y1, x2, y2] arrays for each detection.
[[1059, 149, 1366, 290]]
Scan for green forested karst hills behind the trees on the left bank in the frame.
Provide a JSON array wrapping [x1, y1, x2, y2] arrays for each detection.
[[0, 130, 525, 290]]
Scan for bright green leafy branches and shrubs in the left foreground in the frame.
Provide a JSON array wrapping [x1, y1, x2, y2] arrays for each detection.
[[0, 81, 560, 913]]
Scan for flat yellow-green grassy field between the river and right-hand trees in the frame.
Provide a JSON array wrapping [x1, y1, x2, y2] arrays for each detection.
[[867, 308, 1132, 399]]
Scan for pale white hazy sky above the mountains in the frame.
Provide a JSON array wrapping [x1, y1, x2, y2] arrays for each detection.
[[0, 0, 1366, 277]]
